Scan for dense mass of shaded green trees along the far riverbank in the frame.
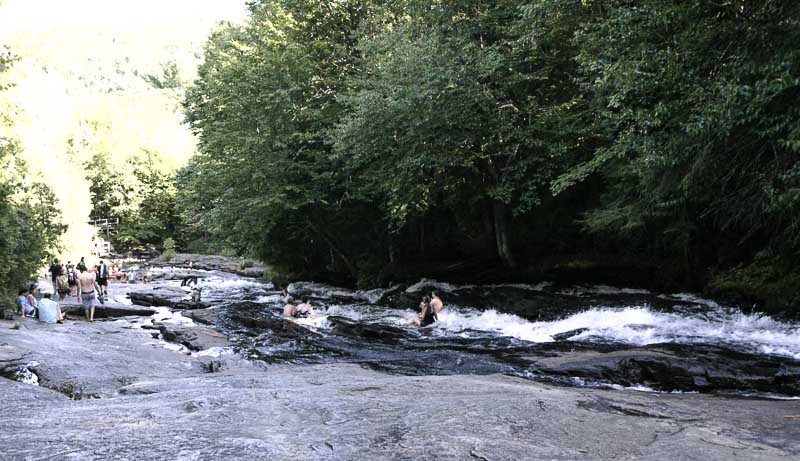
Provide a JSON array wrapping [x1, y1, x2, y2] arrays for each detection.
[[177, 0, 800, 302]]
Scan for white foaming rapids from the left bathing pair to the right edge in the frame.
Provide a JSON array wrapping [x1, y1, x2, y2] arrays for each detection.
[[284, 288, 800, 360]]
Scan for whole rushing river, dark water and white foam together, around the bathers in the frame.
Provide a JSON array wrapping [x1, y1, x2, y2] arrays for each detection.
[[158, 273, 800, 394]]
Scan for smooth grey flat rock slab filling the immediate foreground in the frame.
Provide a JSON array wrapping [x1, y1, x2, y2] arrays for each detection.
[[0, 364, 800, 460]]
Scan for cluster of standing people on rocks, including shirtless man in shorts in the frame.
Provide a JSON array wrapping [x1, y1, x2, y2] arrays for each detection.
[[49, 257, 109, 322]]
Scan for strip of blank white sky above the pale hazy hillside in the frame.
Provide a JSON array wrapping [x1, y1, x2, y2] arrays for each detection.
[[0, 0, 246, 35]]
